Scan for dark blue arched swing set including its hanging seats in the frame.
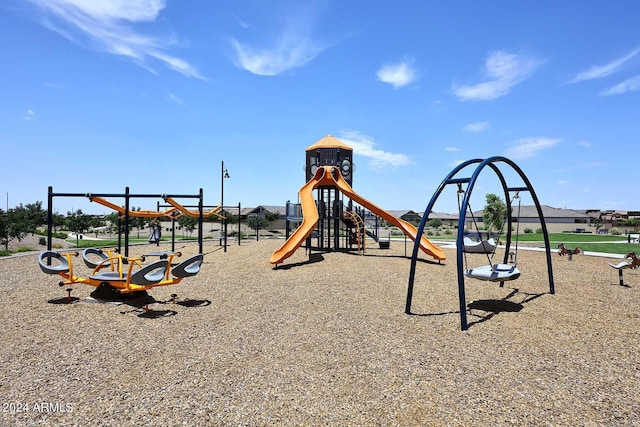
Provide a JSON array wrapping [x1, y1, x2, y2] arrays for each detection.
[[405, 156, 555, 330]]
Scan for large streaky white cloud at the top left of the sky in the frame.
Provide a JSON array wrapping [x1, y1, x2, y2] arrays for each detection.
[[28, 0, 204, 79]]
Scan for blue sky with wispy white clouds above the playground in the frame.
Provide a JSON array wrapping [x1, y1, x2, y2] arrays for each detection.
[[0, 0, 640, 213]]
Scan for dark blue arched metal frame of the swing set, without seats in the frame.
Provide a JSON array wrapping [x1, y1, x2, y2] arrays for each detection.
[[405, 156, 555, 331]]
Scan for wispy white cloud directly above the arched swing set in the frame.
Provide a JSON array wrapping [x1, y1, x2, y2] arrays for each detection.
[[452, 50, 542, 101]]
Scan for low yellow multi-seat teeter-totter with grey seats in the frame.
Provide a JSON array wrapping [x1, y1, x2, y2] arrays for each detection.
[[38, 248, 204, 299]]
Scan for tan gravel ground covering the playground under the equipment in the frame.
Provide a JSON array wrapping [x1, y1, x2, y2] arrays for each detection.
[[0, 240, 640, 426]]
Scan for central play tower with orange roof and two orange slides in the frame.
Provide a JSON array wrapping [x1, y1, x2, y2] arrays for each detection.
[[270, 136, 446, 267]]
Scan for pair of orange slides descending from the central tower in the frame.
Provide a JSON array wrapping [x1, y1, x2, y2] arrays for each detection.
[[270, 166, 446, 264]]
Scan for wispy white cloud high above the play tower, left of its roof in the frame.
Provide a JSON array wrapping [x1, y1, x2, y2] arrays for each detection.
[[231, 6, 326, 76]]
